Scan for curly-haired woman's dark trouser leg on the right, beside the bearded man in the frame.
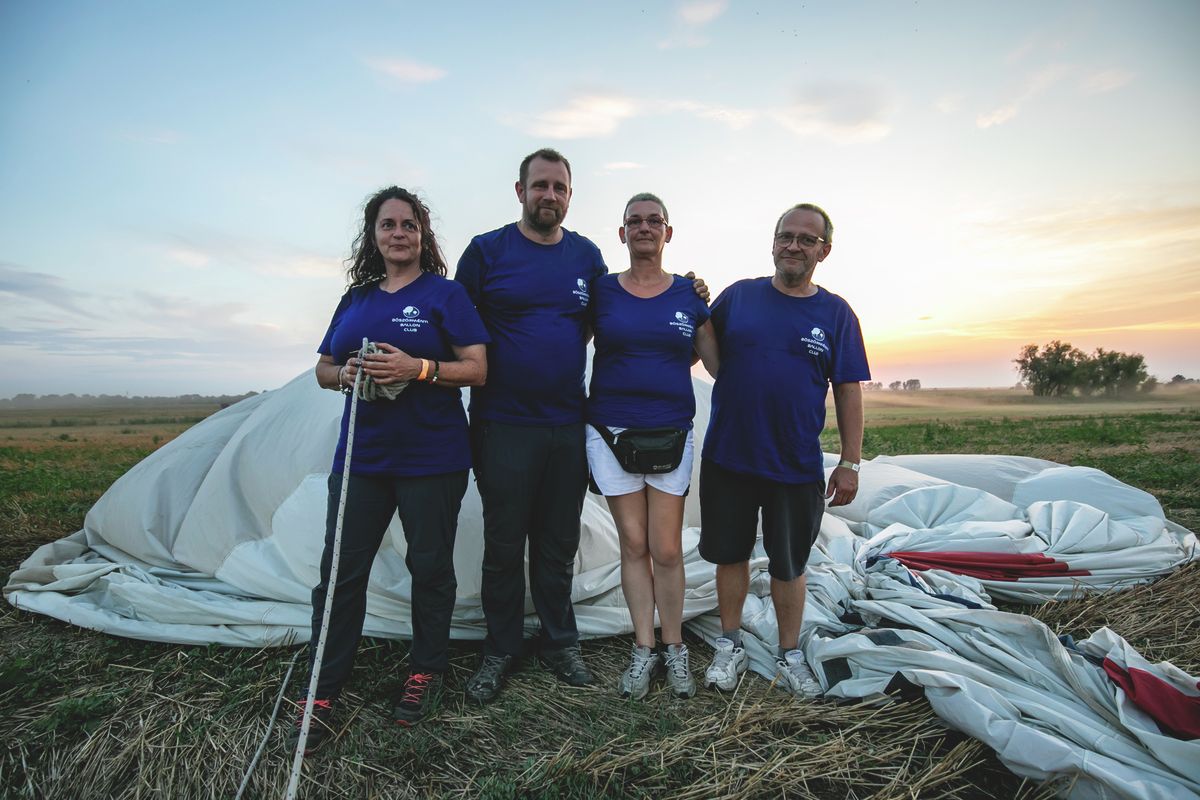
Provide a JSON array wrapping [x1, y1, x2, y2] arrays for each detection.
[[395, 471, 467, 673]]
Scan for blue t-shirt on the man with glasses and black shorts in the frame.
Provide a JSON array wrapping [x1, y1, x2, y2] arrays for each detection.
[[703, 278, 871, 483]]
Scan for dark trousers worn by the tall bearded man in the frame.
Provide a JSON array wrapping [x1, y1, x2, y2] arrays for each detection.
[[474, 422, 588, 656]]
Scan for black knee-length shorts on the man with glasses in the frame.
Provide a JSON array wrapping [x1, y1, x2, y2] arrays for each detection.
[[700, 458, 824, 581]]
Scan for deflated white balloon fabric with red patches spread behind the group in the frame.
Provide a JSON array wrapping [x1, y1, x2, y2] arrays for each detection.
[[4, 373, 1200, 798]]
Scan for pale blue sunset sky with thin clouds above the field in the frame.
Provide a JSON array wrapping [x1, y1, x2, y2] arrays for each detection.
[[0, 0, 1200, 397]]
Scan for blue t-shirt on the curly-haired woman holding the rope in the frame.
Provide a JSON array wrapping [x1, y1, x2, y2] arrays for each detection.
[[318, 272, 487, 477]]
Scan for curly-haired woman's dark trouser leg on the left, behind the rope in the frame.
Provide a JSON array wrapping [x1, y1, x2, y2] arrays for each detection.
[[308, 475, 396, 699]]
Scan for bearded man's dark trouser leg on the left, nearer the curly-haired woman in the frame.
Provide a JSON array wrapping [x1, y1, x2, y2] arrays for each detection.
[[475, 422, 552, 657]]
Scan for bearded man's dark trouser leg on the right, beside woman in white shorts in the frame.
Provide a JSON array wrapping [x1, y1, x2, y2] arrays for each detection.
[[529, 423, 588, 650]]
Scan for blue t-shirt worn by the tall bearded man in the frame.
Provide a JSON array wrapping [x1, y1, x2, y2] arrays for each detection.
[[455, 223, 608, 425]]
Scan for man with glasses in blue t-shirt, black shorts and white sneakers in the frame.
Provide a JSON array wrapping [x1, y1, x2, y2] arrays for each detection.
[[700, 203, 871, 697]]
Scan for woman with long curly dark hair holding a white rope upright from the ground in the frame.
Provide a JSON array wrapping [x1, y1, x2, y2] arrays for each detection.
[[293, 186, 488, 752]]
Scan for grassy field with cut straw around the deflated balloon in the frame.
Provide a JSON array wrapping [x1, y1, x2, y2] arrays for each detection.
[[0, 390, 1200, 798]]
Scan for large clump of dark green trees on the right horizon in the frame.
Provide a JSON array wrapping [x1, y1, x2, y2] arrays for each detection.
[[1013, 339, 1158, 397]]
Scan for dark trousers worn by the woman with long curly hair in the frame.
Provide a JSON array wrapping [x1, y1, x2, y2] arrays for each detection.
[[308, 470, 467, 699]]
